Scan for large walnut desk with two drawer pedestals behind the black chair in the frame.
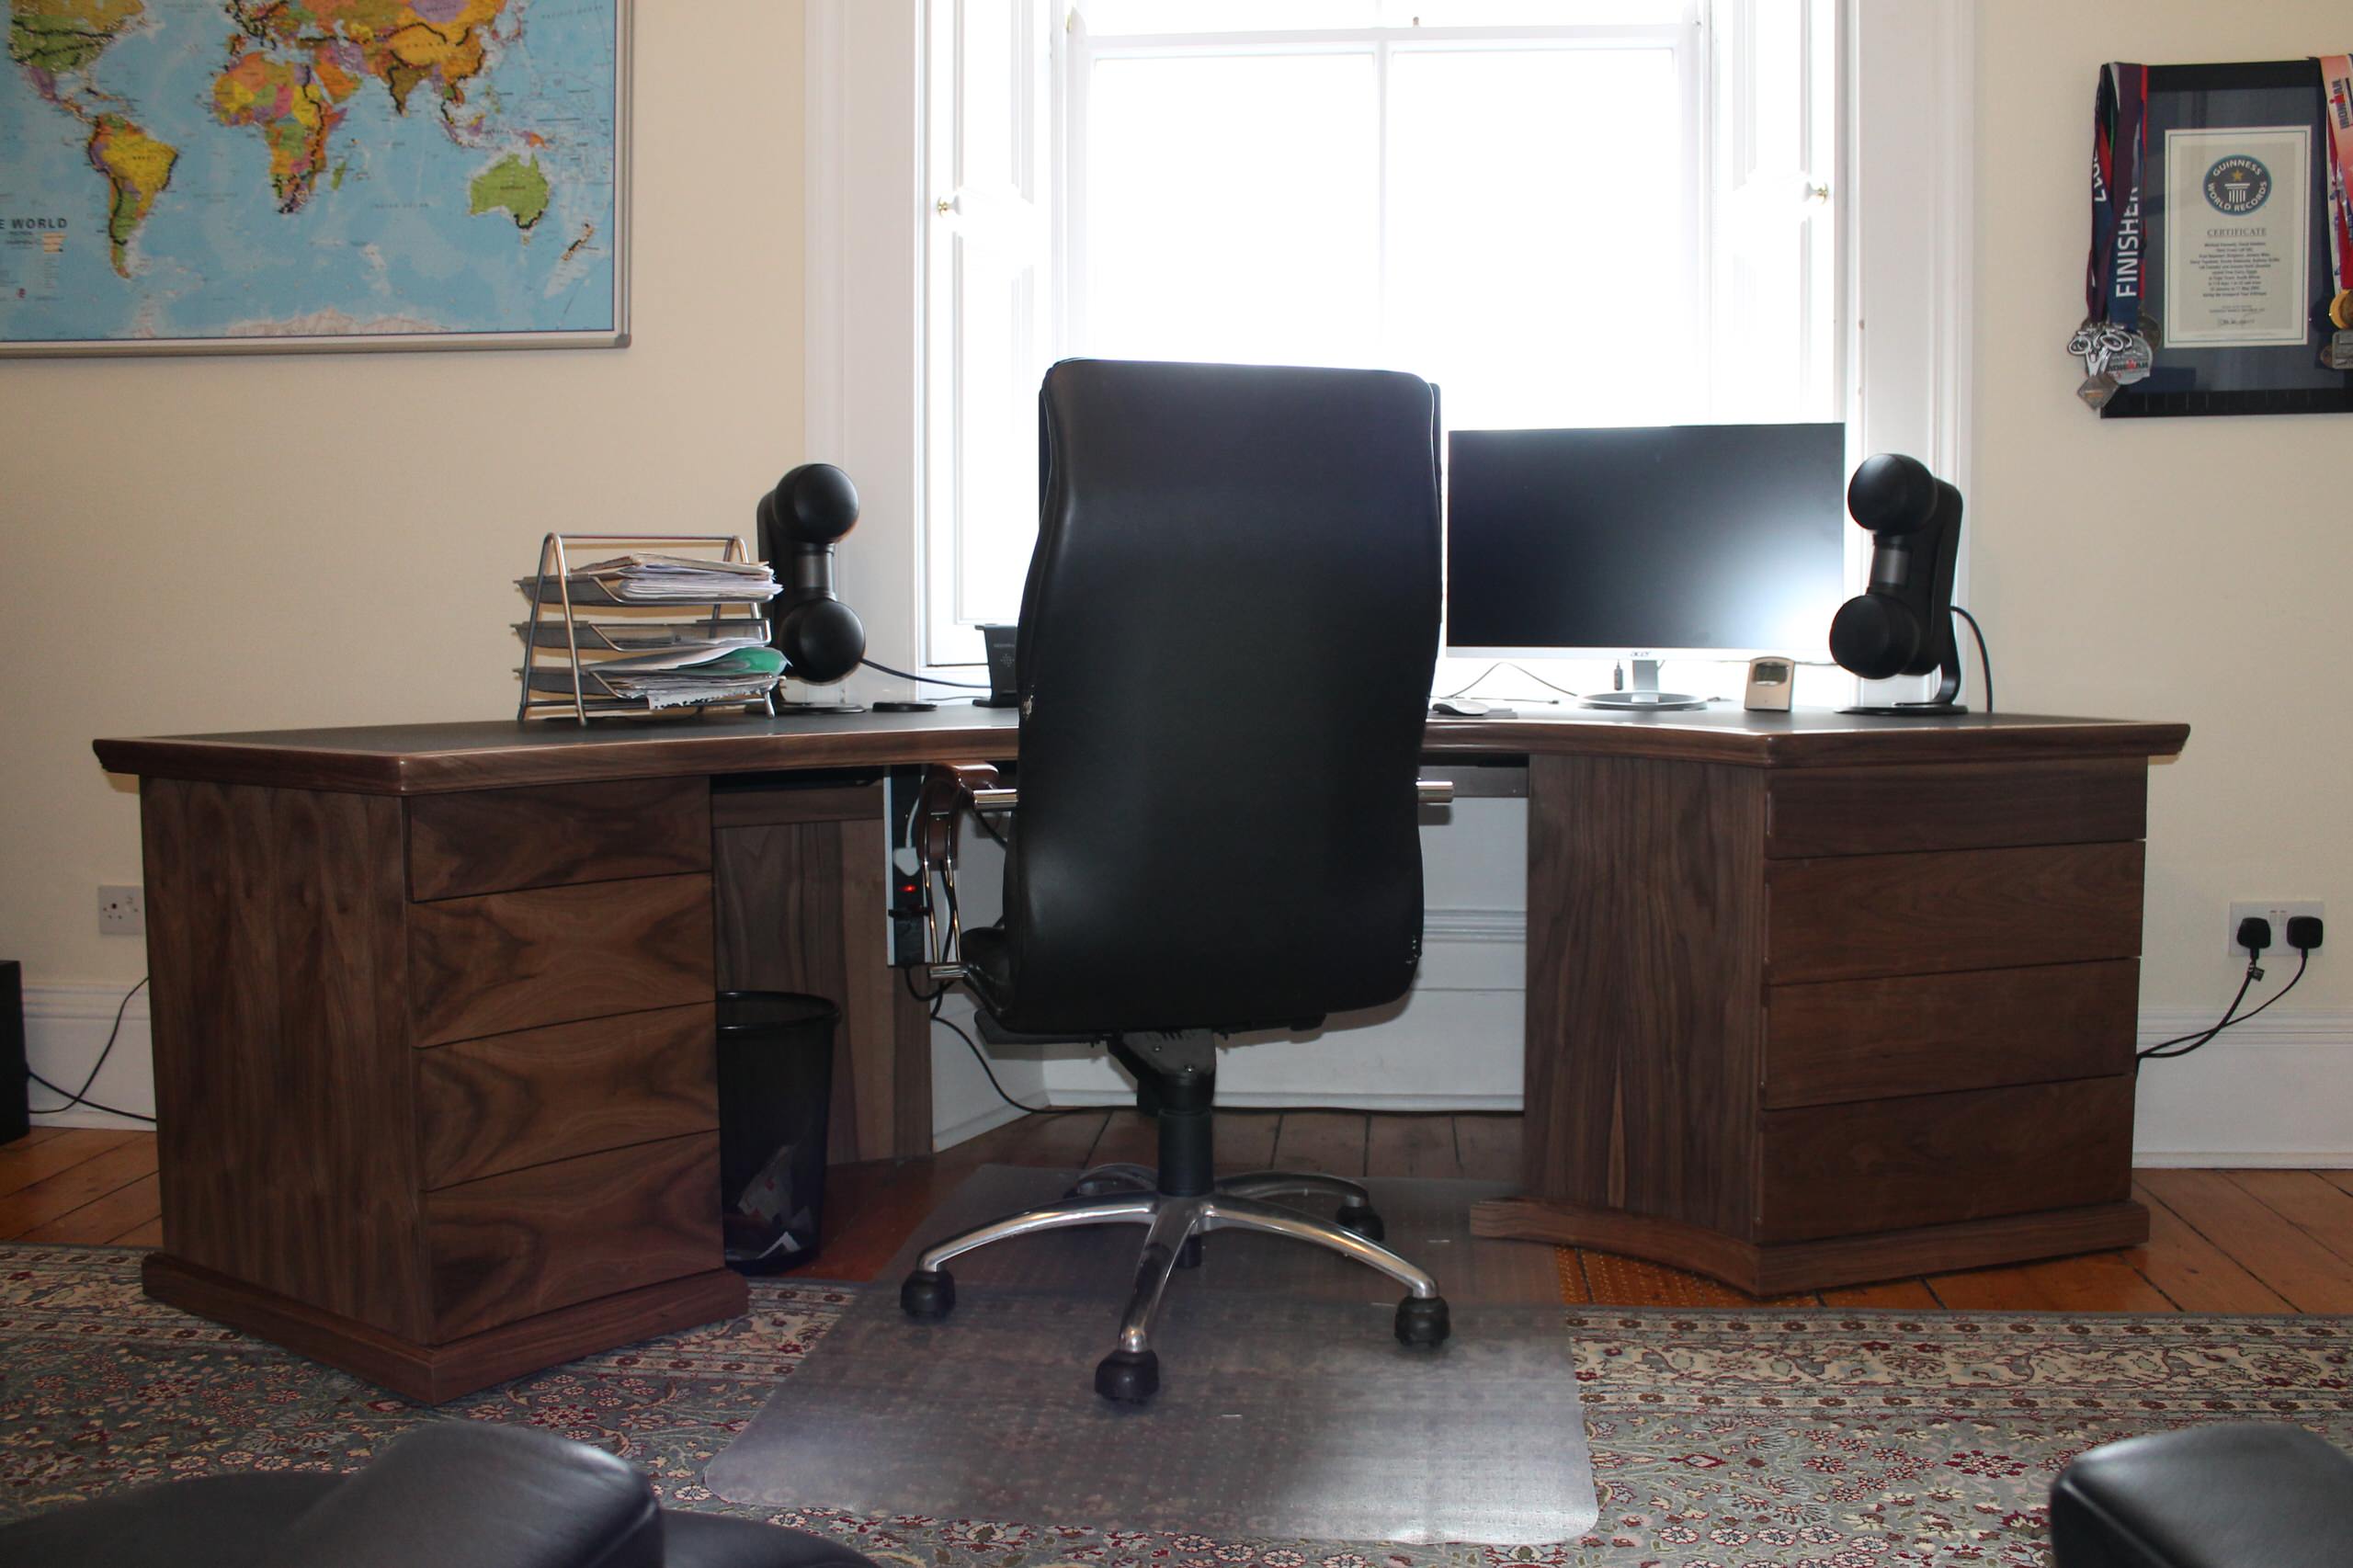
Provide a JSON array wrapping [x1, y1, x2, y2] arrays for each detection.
[[97, 706, 2188, 1401]]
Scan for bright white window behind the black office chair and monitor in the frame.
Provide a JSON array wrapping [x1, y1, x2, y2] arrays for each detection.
[[925, 0, 1840, 664]]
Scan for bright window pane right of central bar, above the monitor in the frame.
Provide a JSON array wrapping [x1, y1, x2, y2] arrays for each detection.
[[1388, 50, 1709, 428]]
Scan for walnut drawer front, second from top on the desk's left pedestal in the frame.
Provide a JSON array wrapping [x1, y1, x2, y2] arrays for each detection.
[[409, 873, 715, 1045]]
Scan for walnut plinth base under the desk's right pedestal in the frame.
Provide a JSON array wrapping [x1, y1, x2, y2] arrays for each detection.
[[1471, 1199, 2148, 1295]]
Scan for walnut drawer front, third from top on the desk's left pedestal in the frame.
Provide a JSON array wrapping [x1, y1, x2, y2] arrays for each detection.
[[416, 1003, 720, 1189]]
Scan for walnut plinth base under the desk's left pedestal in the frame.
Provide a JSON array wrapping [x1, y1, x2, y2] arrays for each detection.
[[139, 1253, 751, 1405]]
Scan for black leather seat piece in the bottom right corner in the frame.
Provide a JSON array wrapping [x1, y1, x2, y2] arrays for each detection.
[[2052, 1422, 2353, 1568]]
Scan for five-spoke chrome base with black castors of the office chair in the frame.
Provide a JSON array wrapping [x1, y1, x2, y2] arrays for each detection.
[[899, 1165, 1449, 1403]]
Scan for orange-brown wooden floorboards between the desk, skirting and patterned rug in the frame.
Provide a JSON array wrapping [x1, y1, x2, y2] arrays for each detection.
[[14, 1111, 2353, 1312]]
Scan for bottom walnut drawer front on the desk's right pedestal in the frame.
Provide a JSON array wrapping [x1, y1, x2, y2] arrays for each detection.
[[1757, 1074, 2131, 1241]]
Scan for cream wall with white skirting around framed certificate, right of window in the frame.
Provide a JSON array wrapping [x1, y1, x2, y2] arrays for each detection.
[[1967, 0, 2353, 1163]]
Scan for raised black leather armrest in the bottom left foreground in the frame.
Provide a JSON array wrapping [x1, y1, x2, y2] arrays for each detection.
[[259, 1420, 664, 1568]]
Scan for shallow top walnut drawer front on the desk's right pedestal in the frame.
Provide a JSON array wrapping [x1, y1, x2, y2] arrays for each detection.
[[1765, 758, 2148, 859]]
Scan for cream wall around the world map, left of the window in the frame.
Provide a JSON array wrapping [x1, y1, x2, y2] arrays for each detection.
[[0, 0, 805, 1125]]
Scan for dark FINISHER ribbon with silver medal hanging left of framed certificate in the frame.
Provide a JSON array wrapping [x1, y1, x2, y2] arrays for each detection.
[[2066, 62, 2158, 407]]
